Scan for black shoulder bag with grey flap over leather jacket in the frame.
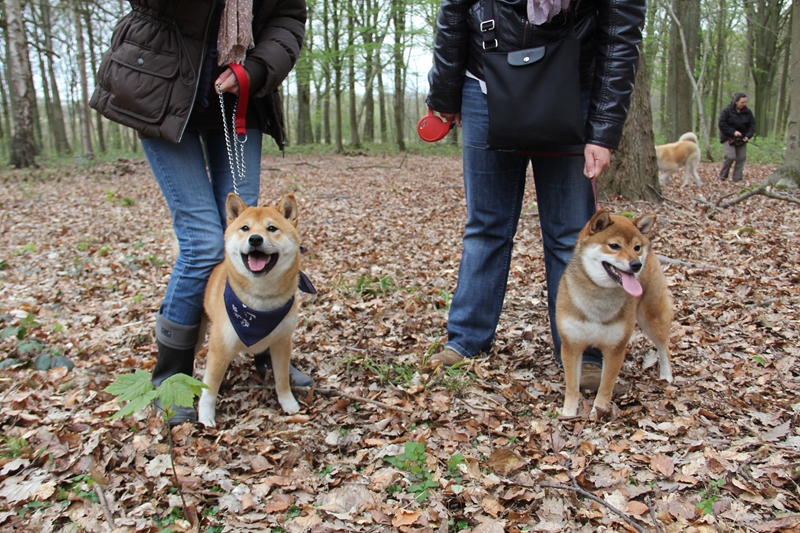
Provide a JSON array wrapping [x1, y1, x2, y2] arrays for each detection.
[[481, 0, 586, 150]]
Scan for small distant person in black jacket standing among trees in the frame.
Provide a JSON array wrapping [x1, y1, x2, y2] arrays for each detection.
[[718, 93, 756, 181]]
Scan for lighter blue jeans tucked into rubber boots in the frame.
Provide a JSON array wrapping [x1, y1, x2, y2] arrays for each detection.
[[142, 129, 261, 326]]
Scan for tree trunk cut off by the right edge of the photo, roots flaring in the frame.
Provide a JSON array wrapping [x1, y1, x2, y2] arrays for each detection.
[[769, 1, 800, 185]]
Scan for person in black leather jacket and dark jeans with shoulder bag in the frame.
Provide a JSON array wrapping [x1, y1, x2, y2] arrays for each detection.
[[427, 0, 645, 388]]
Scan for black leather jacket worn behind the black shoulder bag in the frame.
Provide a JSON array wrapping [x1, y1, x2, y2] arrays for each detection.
[[427, 0, 646, 150]]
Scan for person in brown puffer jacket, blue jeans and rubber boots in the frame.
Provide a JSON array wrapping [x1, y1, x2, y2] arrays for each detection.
[[91, 0, 312, 425]]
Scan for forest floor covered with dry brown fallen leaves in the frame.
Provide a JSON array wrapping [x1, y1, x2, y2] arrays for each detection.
[[0, 155, 800, 533]]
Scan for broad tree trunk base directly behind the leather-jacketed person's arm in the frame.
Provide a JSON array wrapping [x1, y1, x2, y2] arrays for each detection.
[[597, 55, 661, 201]]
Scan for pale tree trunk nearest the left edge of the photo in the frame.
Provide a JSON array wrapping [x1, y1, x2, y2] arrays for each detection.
[[4, 0, 36, 168]]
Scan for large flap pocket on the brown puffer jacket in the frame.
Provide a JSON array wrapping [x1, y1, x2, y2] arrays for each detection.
[[105, 41, 179, 123]]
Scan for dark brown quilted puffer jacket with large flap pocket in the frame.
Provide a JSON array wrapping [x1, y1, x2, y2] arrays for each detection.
[[90, 0, 306, 148]]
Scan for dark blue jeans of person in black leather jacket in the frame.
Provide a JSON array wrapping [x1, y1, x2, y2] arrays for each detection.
[[447, 78, 599, 362]]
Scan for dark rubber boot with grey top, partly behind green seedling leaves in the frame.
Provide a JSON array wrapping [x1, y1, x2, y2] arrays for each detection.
[[151, 314, 200, 426]]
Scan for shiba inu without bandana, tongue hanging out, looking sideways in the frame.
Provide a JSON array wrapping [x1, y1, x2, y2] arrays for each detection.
[[556, 209, 672, 419]]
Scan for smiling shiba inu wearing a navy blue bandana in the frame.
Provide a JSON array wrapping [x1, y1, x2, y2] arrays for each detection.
[[198, 194, 313, 426]]
